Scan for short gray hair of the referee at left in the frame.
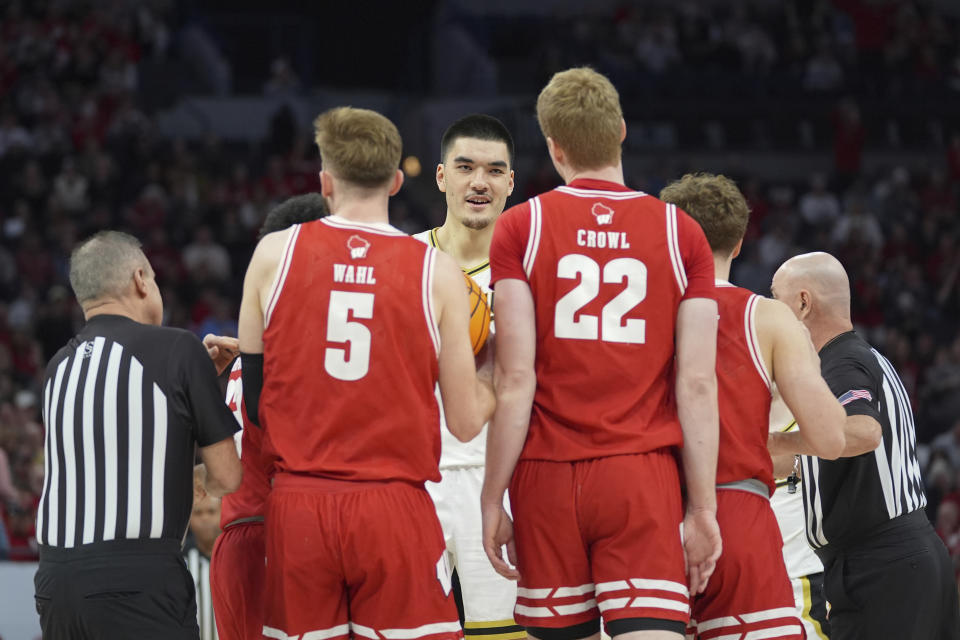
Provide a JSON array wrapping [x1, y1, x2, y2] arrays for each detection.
[[70, 231, 151, 304]]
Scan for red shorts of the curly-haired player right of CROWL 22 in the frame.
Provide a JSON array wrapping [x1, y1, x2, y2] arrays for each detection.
[[691, 489, 803, 640]]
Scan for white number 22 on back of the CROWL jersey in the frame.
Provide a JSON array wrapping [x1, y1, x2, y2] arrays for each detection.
[[553, 253, 647, 344]]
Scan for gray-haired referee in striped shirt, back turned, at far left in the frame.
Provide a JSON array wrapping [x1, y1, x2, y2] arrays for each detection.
[[35, 231, 242, 640]]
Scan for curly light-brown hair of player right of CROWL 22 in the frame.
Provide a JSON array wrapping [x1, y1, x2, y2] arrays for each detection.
[[660, 173, 750, 257]]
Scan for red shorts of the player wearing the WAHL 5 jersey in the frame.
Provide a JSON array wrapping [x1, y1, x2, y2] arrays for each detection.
[[263, 474, 463, 640]]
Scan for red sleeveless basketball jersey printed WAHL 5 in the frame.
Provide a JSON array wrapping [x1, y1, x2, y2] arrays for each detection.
[[260, 216, 440, 483]]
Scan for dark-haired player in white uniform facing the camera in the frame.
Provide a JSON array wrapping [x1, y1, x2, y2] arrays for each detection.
[[414, 114, 526, 640]]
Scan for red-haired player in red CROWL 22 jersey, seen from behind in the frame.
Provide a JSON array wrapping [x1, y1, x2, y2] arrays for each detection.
[[481, 68, 721, 640]]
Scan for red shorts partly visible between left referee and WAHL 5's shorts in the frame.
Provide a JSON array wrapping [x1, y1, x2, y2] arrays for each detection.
[[210, 522, 264, 640]]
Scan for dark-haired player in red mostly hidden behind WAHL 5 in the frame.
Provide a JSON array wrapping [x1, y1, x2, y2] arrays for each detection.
[[210, 193, 327, 640]]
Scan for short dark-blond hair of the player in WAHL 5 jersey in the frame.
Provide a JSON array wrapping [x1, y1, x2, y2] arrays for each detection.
[[313, 107, 403, 188]]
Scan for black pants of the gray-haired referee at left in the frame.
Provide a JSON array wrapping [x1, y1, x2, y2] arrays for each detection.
[[34, 540, 200, 640]]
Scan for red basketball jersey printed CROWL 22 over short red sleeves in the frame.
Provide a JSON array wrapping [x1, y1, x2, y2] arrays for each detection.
[[490, 180, 714, 461]]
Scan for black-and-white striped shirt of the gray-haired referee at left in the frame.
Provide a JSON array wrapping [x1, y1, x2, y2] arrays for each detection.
[[37, 315, 237, 548]]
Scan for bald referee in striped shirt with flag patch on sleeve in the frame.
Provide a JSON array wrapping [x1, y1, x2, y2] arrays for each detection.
[[770, 253, 960, 640]]
